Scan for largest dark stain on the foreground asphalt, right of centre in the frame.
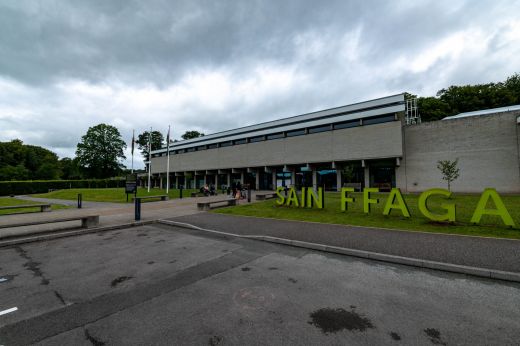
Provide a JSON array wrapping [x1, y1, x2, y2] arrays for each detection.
[[308, 308, 374, 334]]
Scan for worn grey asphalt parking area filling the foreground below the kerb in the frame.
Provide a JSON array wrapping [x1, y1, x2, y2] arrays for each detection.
[[0, 225, 520, 345]]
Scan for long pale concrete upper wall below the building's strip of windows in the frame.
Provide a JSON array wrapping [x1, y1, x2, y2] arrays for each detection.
[[152, 121, 403, 173]]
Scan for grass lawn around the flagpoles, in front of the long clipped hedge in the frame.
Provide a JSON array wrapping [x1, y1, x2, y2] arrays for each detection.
[[33, 187, 199, 203]]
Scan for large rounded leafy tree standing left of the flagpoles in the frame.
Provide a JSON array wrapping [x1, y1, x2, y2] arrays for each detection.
[[76, 124, 126, 178]]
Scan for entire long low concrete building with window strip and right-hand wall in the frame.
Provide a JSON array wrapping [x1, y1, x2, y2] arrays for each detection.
[[145, 94, 520, 193]]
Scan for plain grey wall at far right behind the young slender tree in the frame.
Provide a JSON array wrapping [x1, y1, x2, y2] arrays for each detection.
[[402, 112, 520, 193]]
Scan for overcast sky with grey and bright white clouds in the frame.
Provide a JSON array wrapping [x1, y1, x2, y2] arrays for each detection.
[[0, 0, 520, 167]]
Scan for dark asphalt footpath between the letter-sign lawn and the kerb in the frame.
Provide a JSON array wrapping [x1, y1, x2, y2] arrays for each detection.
[[172, 213, 520, 272]]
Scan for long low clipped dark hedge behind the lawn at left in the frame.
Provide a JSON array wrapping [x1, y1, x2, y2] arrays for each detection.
[[0, 179, 125, 196]]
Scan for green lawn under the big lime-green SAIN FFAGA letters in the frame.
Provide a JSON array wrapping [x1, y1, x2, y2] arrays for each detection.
[[214, 192, 520, 239]]
